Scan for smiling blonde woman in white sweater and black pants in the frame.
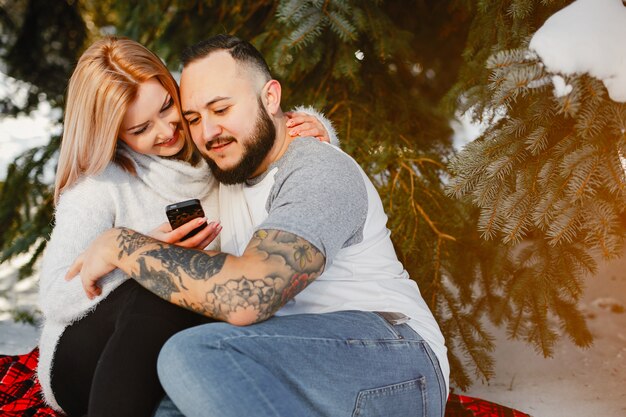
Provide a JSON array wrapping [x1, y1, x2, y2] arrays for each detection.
[[38, 37, 333, 416]]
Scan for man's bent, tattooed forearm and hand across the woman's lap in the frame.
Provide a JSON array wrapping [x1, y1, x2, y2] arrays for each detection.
[[68, 229, 325, 325]]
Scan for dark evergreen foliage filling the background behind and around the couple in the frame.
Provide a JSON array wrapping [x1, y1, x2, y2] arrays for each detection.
[[0, 0, 623, 388]]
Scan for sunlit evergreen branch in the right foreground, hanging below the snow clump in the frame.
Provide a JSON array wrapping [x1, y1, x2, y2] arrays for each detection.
[[449, 2, 626, 356]]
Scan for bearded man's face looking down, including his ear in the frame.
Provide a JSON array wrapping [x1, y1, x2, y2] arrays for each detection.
[[180, 51, 276, 184]]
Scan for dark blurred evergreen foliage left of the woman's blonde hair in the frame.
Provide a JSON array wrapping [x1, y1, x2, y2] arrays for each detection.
[[0, 0, 87, 277]]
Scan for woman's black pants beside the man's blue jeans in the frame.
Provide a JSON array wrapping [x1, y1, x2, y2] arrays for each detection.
[[52, 279, 208, 417]]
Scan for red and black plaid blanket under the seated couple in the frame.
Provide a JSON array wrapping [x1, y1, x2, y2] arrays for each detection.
[[0, 348, 530, 417]]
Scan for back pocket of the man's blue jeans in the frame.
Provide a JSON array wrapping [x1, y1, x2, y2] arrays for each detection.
[[352, 377, 426, 417]]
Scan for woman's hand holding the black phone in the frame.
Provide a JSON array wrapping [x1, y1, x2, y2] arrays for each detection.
[[148, 218, 222, 249]]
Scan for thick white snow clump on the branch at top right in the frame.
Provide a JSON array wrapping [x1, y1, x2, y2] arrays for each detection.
[[530, 0, 626, 102]]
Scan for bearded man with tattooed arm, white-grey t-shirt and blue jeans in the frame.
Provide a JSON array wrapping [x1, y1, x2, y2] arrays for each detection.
[[70, 35, 448, 417]]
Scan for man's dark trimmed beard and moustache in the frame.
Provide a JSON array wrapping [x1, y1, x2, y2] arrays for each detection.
[[204, 98, 276, 184]]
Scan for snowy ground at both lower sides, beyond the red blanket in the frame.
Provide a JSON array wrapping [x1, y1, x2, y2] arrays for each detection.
[[0, 249, 626, 417]]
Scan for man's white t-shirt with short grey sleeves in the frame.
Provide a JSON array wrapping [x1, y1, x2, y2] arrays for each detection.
[[220, 138, 449, 387]]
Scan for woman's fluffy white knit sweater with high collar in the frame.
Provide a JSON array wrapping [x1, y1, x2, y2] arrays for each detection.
[[38, 147, 219, 410]]
